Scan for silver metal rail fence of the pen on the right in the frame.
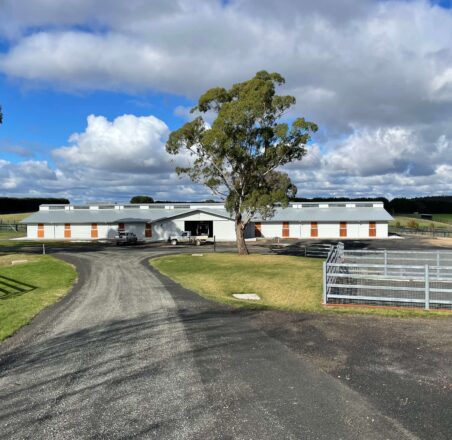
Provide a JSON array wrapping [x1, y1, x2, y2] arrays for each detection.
[[323, 244, 452, 309]]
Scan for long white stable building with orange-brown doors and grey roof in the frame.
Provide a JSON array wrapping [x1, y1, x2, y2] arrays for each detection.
[[22, 202, 392, 241]]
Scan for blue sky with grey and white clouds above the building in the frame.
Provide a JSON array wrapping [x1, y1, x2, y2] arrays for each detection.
[[0, 0, 452, 202]]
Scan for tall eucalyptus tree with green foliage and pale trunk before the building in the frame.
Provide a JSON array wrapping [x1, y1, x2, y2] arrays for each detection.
[[166, 71, 317, 254]]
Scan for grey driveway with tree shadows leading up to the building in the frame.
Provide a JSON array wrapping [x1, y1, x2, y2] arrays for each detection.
[[0, 248, 417, 440]]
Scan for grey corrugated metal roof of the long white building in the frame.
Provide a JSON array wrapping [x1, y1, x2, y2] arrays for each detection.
[[22, 207, 392, 224]]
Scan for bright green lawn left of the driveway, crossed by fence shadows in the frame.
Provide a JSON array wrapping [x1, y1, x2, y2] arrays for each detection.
[[0, 254, 77, 341]]
